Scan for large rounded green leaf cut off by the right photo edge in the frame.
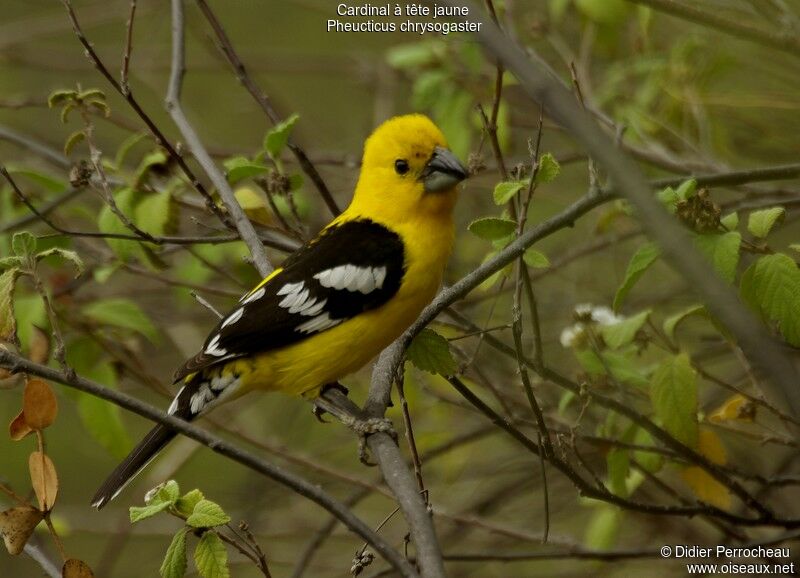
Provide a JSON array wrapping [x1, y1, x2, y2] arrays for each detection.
[[739, 253, 800, 347]]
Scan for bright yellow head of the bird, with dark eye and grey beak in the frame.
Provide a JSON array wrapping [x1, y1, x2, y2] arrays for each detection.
[[347, 114, 467, 225]]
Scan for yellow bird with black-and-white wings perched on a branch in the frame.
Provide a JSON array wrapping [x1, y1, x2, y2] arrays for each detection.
[[91, 114, 467, 509]]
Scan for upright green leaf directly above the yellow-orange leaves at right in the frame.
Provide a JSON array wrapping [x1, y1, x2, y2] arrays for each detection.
[[650, 353, 697, 448]]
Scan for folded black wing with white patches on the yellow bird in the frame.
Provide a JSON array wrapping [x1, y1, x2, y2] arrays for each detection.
[[175, 219, 405, 381]]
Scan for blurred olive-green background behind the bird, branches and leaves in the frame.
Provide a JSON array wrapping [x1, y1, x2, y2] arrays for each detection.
[[0, 0, 800, 578]]
